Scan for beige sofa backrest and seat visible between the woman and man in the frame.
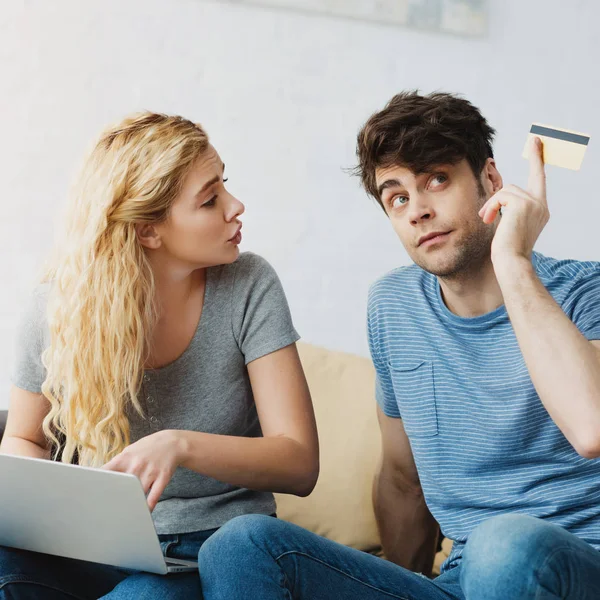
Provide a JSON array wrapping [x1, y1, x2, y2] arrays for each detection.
[[277, 343, 451, 573]]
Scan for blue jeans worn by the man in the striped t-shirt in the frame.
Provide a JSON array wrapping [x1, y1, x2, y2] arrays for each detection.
[[199, 514, 600, 600]]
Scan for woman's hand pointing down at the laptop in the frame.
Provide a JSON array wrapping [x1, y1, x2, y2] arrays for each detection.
[[102, 429, 183, 510]]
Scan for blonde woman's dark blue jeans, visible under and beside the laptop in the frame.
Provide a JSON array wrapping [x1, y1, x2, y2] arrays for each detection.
[[0, 530, 216, 600]]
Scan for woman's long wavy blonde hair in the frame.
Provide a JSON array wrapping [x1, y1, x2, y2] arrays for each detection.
[[42, 112, 209, 466]]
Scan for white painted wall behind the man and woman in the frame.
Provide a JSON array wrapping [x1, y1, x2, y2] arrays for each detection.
[[0, 0, 600, 408]]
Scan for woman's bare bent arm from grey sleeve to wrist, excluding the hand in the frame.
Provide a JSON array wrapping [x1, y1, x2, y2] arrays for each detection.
[[181, 344, 319, 496]]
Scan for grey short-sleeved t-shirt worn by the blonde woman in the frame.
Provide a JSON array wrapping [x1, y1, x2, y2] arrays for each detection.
[[12, 252, 299, 534]]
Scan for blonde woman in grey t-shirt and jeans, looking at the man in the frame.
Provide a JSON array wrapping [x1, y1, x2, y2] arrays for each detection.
[[0, 113, 319, 600]]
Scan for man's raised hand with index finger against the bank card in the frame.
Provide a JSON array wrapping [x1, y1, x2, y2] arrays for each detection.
[[479, 137, 550, 269]]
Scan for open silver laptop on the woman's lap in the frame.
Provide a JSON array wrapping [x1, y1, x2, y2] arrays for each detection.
[[0, 454, 198, 574]]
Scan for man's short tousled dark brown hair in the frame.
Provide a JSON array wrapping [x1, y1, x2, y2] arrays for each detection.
[[355, 91, 496, 209]]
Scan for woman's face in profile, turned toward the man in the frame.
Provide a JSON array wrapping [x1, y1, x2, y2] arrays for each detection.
[[154, 146, 244, 269]]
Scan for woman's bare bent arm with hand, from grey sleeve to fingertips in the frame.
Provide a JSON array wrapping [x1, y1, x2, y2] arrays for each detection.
[[105, 344, 319, 508]]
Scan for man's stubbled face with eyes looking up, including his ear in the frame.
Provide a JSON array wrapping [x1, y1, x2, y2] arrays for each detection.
[[375, 159, 502, 278]]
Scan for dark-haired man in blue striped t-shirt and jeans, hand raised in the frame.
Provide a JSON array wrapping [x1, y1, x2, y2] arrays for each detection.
[[200, 93, 600, 600]]
